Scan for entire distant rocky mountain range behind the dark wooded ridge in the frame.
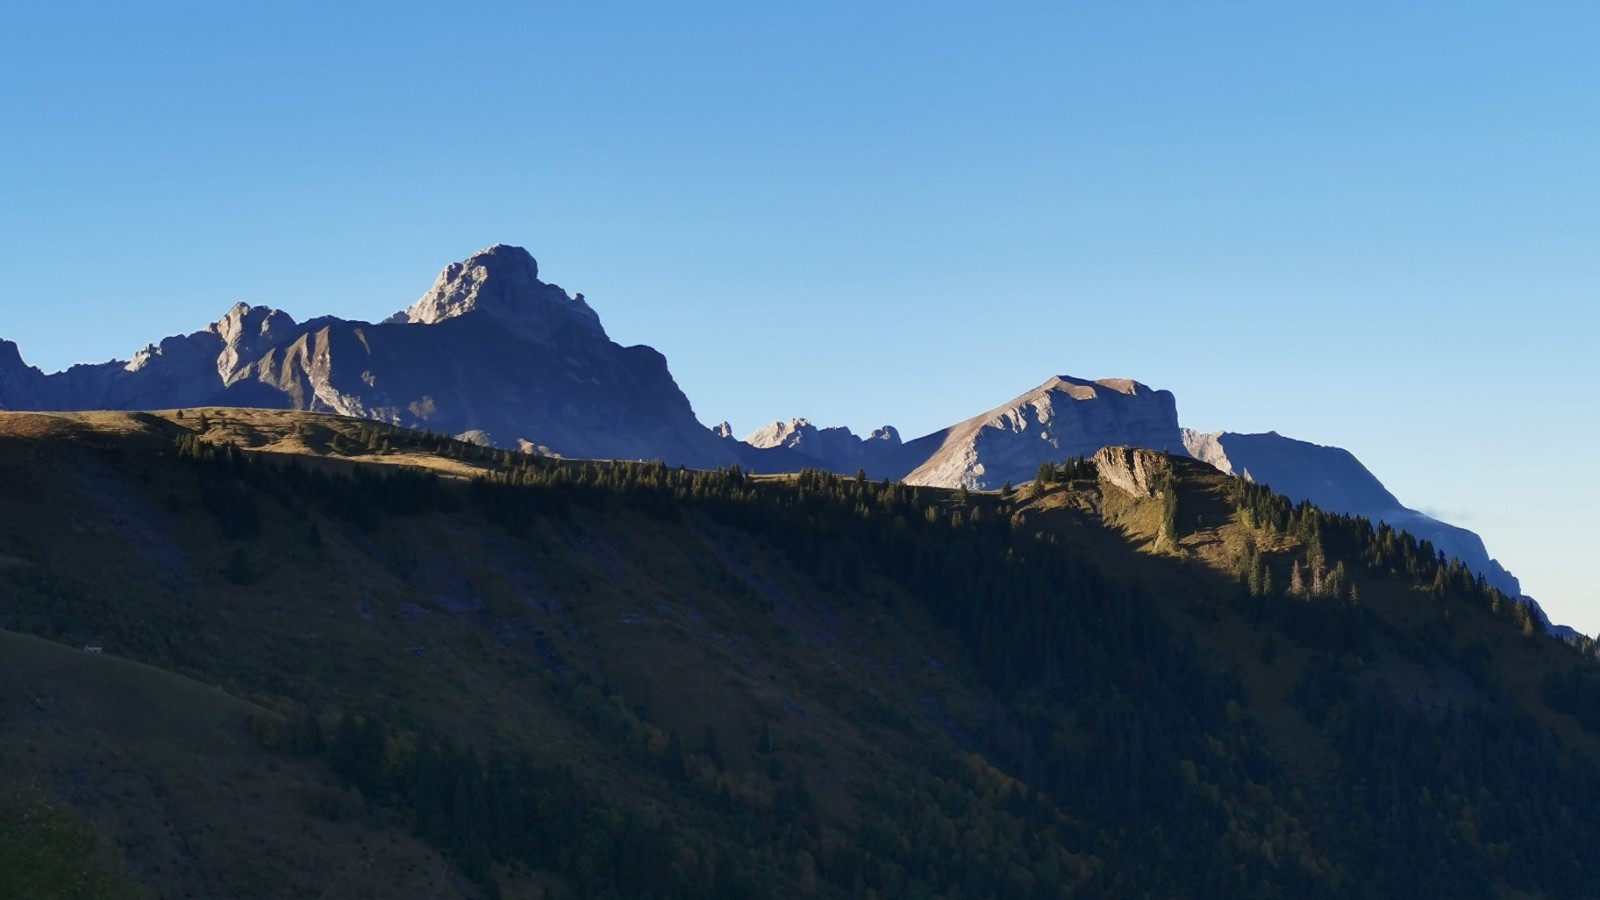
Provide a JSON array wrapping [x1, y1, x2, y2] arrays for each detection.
[[0, 245, 1542, 617]]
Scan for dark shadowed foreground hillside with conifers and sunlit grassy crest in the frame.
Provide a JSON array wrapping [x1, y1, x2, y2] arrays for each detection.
[[0, 410, 1600, 897]]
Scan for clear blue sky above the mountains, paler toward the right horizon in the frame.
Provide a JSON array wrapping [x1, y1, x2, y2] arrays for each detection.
[[0, 0, 1600, 633]]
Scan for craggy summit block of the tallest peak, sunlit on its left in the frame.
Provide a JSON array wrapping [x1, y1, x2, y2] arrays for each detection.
[[384, 243, 605, 338]]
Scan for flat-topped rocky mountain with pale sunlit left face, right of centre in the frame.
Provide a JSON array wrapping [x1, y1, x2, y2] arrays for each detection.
[[902, 375, 1187, 490]]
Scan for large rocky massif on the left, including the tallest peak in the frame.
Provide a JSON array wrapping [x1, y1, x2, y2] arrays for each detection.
[[0, 245, 738, 468]]
